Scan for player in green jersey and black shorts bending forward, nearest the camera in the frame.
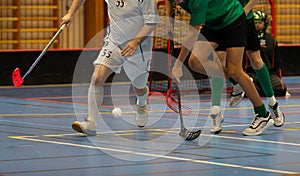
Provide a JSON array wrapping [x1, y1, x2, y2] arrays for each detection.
[[166, 0, 273, 135]]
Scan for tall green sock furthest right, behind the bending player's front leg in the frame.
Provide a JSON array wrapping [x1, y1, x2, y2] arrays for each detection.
[[255, 63, 274, 97]]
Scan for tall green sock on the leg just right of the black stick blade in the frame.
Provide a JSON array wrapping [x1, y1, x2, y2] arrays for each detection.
[[211, 77, 224, 106]]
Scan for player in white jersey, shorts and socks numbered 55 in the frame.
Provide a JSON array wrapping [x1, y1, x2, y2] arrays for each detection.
[[62, 0, 159, 136]]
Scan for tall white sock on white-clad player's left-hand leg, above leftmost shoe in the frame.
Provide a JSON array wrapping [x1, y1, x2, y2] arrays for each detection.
[[87, 85, 104, 122]]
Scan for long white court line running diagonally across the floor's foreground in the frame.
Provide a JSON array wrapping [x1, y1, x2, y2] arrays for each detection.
[[10, 136, 299, 174]]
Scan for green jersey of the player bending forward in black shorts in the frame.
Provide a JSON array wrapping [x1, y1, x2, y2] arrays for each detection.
[[179, 0, 244, 30]]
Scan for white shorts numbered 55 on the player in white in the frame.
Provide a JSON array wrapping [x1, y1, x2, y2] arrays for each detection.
[[94, 42, 152, 89]]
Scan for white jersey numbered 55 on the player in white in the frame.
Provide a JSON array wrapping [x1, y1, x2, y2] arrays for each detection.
[[105, 0, 159, 45]]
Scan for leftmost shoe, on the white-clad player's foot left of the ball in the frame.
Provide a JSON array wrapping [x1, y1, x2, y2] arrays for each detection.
[[72, 119, 97, 136]]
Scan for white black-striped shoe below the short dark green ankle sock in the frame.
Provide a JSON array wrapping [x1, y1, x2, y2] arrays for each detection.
[[243, 113, 274, 136]]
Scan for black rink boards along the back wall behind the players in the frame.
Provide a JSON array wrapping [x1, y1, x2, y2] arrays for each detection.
[[0, 46, 300, 86]]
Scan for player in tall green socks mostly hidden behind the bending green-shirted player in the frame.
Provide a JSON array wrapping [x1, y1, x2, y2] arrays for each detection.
[[207, 0, 285, 133]]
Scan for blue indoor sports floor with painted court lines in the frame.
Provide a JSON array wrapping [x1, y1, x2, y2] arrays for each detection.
[[0, 77, 300, 176]]
